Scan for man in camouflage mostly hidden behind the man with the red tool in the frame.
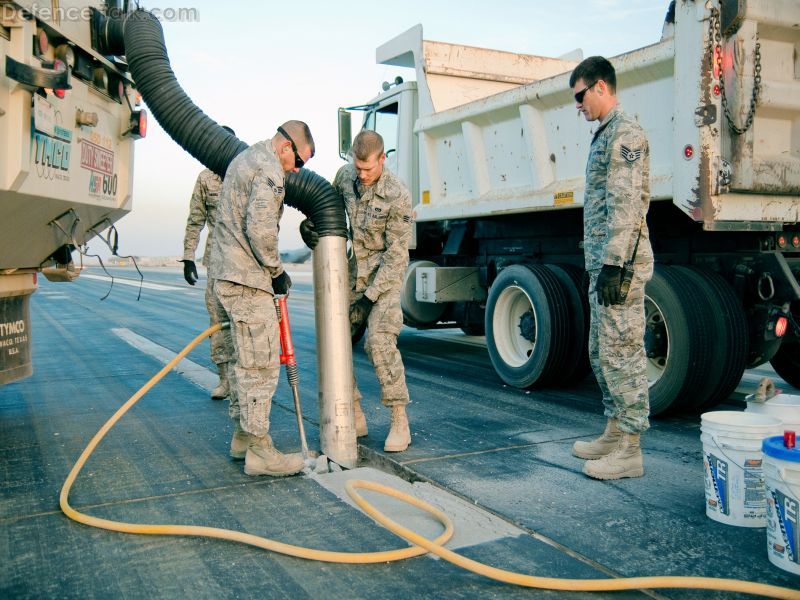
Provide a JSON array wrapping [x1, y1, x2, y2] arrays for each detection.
[[182, 166, 232, 400]]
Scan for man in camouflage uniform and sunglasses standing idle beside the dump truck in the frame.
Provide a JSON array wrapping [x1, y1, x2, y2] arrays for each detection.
[[570, 57, 653, 479]]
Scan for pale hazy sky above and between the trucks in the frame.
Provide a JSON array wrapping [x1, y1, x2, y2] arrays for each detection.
[[95, 0, 669, 262]]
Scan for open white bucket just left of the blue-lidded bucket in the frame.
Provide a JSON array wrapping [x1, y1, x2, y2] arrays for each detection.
[[700, 411, 783, 527]]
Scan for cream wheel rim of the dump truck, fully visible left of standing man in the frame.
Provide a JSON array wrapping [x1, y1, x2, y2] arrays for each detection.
[[492, 285, 539, 368]]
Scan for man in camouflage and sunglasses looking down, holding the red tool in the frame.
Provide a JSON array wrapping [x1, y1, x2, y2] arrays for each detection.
[[209, 121, 314, 476]]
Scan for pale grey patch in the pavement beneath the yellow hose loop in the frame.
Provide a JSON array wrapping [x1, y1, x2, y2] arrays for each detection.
[[310, 467, 526, 558]]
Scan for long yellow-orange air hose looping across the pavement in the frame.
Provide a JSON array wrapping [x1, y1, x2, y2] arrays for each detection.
[[59, 324, 800, 600]]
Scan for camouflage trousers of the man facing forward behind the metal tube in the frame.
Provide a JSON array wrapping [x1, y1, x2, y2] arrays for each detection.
[[350, 292, 409, 406]]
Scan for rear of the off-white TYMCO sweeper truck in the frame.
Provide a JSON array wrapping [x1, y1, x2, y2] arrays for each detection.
[[0, 0, 147, 384]]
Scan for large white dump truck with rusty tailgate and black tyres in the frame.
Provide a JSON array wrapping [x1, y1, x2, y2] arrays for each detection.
[[339, 0, 800, 414]]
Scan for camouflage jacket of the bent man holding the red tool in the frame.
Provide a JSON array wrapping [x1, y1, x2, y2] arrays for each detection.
[[208, 140, 285, 294]]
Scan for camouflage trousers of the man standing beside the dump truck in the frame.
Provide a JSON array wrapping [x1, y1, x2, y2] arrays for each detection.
[[589, 264, 653, 433]]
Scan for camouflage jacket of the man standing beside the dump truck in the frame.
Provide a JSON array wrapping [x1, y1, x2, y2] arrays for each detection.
[[583, 106, 653, 271]]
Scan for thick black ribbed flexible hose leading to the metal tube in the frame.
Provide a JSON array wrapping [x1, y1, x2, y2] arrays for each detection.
[[96, 10, 347, 237]]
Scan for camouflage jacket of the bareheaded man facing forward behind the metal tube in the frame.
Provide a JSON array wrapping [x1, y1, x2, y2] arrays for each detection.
[[333, 164, 412, 301]]
